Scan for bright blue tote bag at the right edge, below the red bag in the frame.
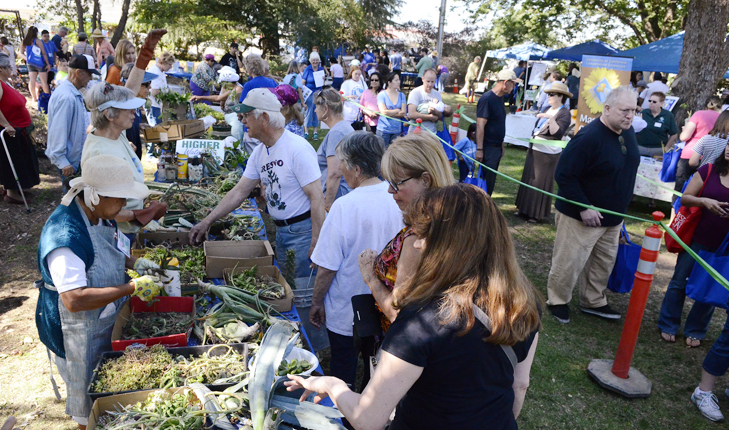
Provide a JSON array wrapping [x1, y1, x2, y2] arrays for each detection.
[[686, 235, 729, 309]]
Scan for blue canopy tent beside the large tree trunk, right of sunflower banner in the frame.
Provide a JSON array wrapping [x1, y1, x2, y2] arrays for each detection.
[[620, 31, 729, 78]]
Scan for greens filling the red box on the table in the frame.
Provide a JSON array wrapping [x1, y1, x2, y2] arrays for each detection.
[[122, 312, 192, 340]]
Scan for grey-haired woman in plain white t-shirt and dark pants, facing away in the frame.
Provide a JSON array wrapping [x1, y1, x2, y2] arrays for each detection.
[[309, 131, 403, 386]]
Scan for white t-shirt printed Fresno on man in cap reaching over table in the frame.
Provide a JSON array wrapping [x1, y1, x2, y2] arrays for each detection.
[[243, 130, 321, 220]]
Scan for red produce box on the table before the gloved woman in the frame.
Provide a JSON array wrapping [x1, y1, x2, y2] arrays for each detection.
[[111, 296, 195, 351]]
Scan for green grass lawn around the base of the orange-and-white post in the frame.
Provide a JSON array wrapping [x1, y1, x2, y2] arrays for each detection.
[[302, 93, 729, 430]]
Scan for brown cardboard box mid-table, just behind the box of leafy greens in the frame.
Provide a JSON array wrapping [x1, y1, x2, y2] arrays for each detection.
[[203, 240, 274, 278]]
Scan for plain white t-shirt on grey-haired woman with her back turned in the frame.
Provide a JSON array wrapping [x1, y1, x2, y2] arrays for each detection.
[[311, 182, 404, 336]]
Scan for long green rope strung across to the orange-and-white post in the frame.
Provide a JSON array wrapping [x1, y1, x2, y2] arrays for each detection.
[[338, 95, 729, 290]]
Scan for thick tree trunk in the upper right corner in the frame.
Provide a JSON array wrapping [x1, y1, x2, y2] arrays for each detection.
[[672, 0, 729, 124]]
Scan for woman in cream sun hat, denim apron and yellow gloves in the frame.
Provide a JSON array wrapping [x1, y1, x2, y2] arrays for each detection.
[[36, 155, 160, 430]]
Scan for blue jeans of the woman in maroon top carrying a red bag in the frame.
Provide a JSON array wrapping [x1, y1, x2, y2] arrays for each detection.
[[658, 242, 712, 339]]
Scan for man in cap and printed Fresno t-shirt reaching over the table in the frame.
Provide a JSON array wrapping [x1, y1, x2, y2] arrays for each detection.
[[190, 88, 324, 281]]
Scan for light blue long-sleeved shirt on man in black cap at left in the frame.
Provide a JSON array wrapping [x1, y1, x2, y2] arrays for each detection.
[[46, 79, 88, 171]]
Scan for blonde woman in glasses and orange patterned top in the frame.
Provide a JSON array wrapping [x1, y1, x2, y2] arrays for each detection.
[[359, 134, 456, 330]]
